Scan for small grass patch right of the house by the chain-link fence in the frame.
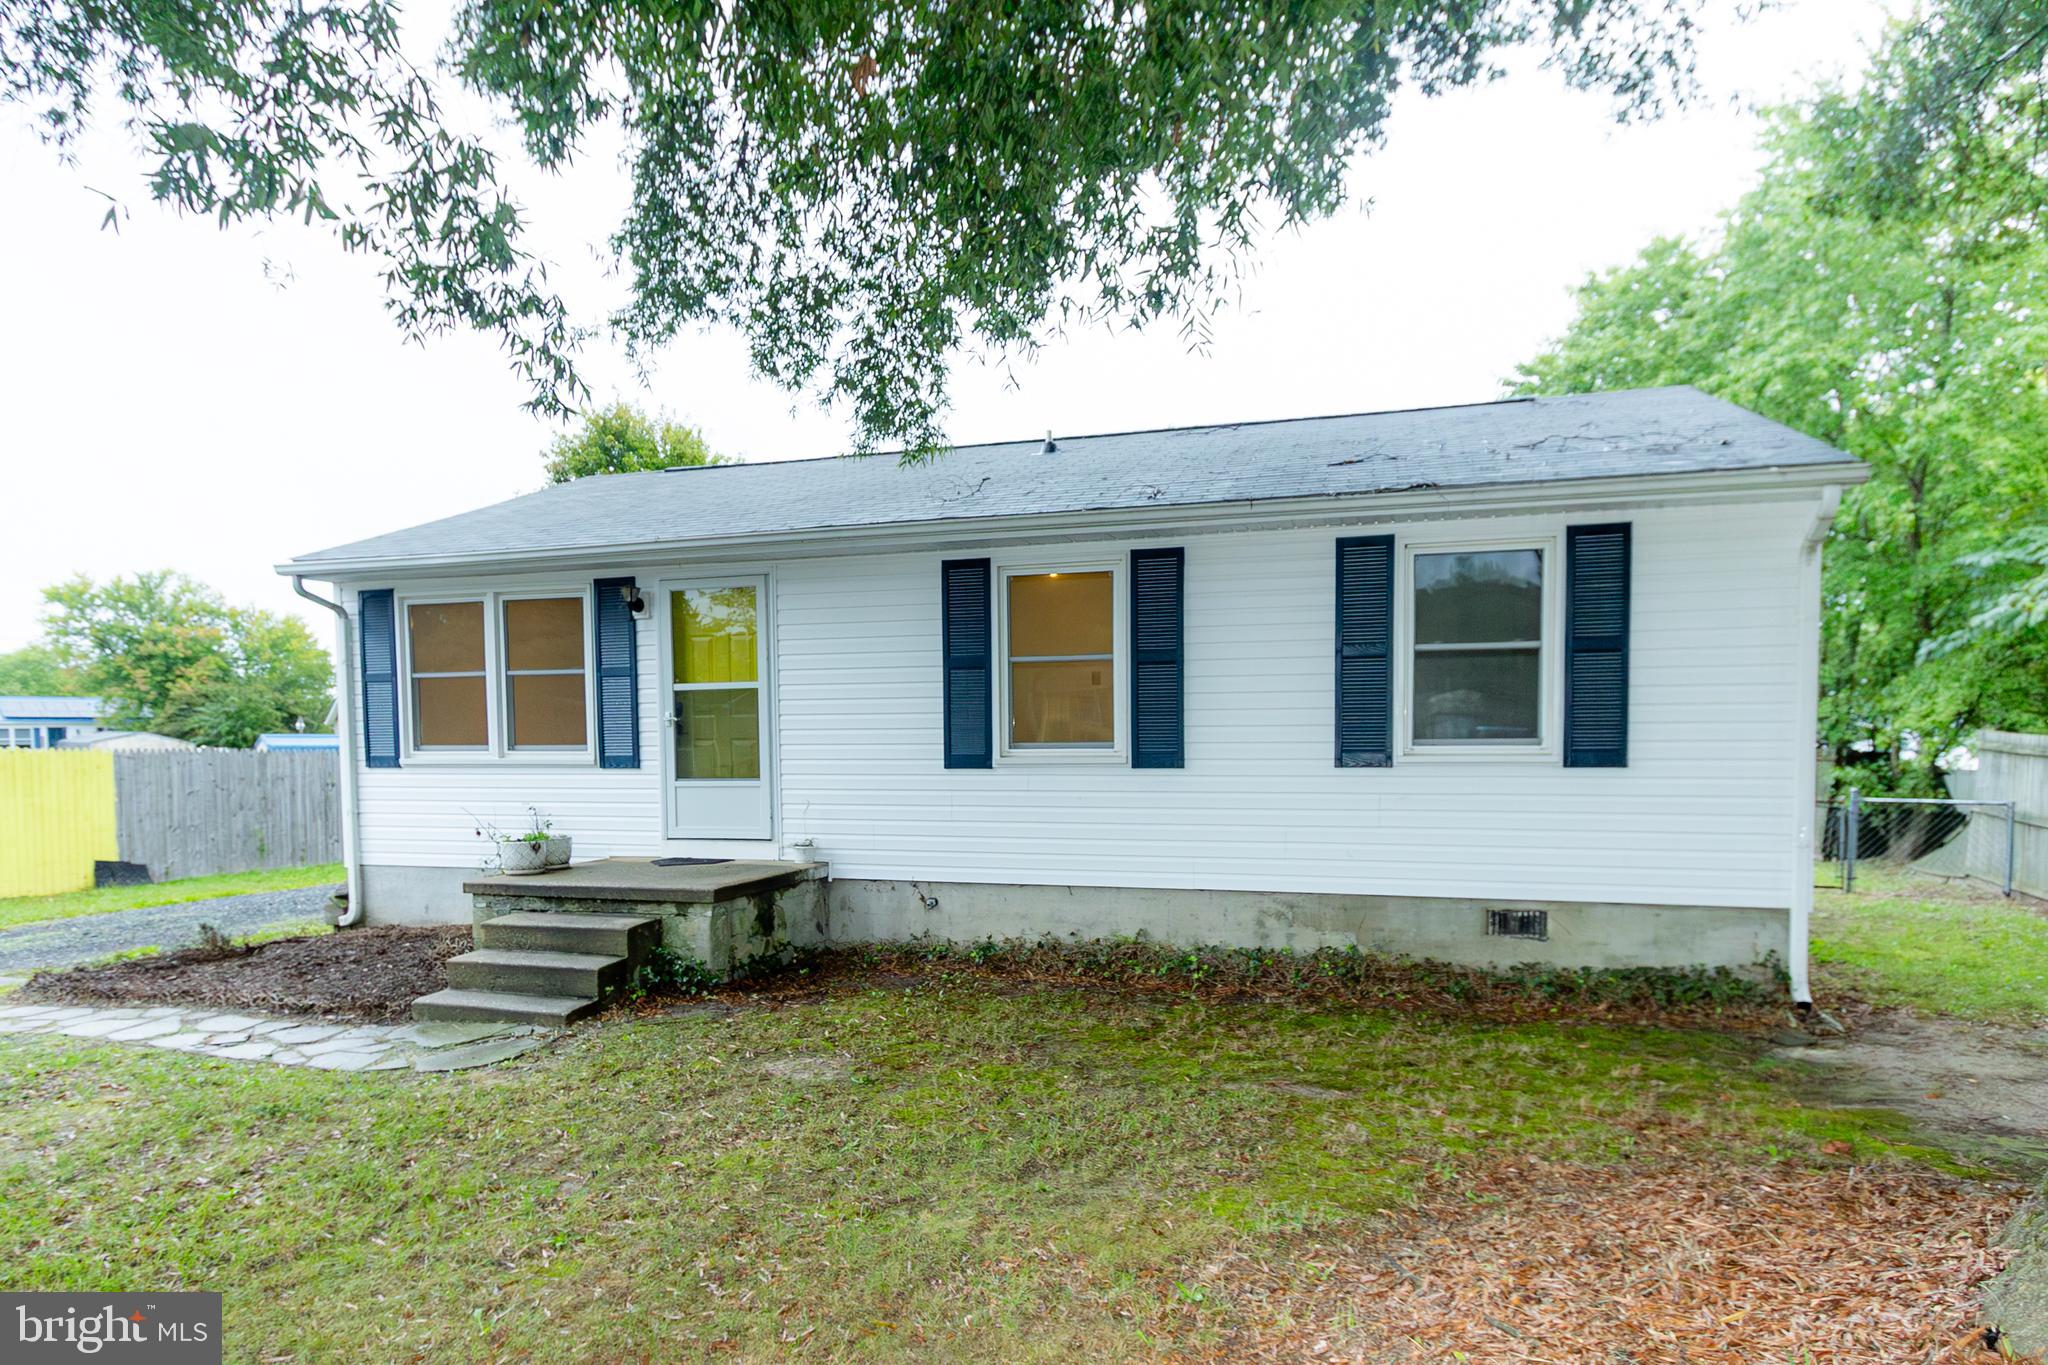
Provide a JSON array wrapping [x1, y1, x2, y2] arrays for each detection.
[[1812, 868, 2048, 1025]]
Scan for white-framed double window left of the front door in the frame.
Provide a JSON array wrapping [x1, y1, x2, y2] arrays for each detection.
[[401, 589, 590, 761]]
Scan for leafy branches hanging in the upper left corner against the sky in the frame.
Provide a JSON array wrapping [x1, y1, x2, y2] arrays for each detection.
[[12, 0, 586, 415]]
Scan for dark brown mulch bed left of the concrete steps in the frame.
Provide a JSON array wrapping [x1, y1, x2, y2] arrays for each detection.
[[14, 925, 471, 1019]]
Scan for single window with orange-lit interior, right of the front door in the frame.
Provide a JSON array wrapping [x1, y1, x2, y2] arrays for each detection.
[[997, 563, 1122, 759]]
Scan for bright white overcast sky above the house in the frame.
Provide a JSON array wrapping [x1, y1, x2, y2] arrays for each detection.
[[0, 0, 1882, 663]]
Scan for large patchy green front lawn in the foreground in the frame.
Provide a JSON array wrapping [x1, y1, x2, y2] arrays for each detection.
[[0, 978, 1998, 1361]]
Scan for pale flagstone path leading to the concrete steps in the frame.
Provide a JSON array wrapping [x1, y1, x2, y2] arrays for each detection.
[[0, 1005, 547, 1070]]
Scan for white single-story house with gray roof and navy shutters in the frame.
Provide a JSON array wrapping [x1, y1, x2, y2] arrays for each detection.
[[281, 389, 1866, 999]]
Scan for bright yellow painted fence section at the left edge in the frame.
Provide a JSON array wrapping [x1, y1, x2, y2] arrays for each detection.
[[0, 749, 115, 896]]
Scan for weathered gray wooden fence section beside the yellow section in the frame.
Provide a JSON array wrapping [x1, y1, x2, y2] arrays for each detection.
[[115, 749, 342, 882]]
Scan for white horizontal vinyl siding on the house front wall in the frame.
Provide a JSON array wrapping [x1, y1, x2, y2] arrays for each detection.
[[348, 499, 1815, 907]]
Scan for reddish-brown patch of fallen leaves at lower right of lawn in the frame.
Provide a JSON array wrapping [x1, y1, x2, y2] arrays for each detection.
[[1202, 1158, 2025, 1365]]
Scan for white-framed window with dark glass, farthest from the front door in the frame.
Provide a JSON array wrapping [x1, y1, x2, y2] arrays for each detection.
[[1405, 542, 1554, 753]]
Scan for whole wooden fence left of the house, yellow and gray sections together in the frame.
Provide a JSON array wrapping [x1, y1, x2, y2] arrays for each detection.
[[0, 749, 342, 896]]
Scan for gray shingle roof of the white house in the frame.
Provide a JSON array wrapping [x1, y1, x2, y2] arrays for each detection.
[[287, 387, 1862, 573]]
